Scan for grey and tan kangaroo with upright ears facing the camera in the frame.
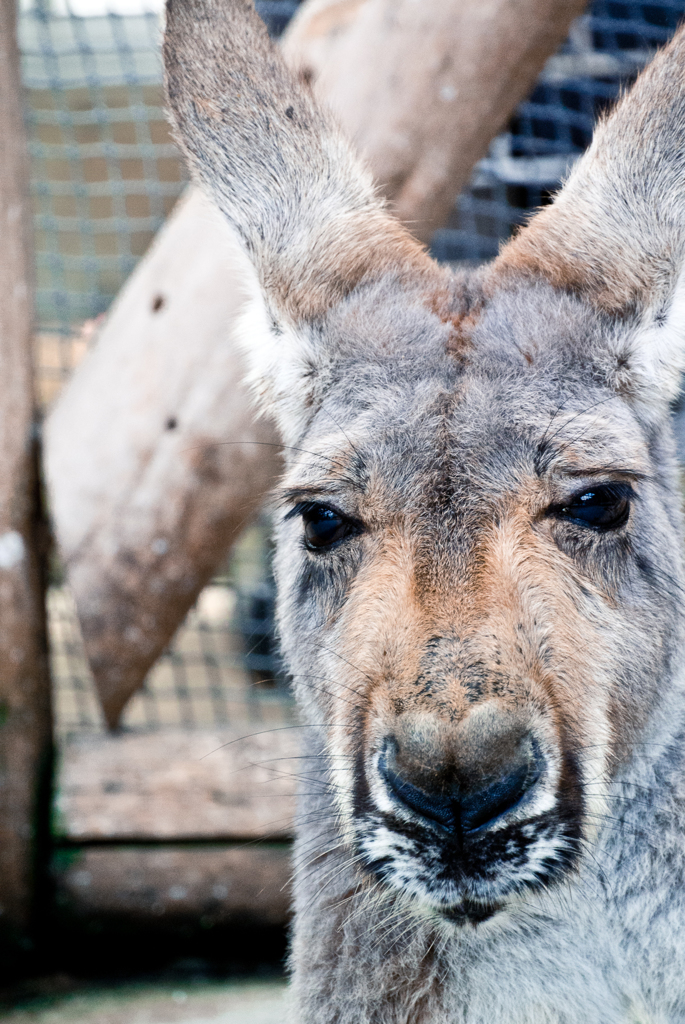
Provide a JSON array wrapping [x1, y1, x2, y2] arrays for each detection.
[[165, 0, 685, 1024]]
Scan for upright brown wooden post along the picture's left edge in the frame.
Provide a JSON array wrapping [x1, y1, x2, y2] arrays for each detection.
[[0, 0, 51, 973]]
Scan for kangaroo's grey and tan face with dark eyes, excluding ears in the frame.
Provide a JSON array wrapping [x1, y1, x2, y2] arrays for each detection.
[[277, 289, 679, 921]]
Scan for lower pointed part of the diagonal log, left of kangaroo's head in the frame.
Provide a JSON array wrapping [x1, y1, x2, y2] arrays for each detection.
[[45, 191, 280, 726]]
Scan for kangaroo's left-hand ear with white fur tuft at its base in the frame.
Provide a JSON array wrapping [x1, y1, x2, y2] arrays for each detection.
[[164, 0, 439, 439]]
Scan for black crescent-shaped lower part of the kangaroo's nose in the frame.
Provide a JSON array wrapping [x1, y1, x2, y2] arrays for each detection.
[[379, 737, 542, 835]]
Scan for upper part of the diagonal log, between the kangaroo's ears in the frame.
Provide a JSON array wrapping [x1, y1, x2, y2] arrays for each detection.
[[284, 0, 587, 242]]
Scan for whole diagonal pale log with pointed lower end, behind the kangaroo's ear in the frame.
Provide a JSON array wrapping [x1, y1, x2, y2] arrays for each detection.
[[46, 0, 585, 727]]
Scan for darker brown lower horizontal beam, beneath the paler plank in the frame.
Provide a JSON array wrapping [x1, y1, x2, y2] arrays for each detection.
[[53, 845, 292, 928]]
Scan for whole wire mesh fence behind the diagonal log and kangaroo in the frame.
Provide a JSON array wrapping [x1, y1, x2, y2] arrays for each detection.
[[18, 0, 685, 734]]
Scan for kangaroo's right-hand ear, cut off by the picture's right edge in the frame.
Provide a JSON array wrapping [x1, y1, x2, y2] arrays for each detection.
[[488, 29, 685, 399]]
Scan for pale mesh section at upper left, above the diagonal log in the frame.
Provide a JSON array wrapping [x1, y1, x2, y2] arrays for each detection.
[[18, 0, 297, 404]]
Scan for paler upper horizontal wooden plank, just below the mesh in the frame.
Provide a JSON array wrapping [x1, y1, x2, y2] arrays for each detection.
[[56, 725, 300, 843]]
